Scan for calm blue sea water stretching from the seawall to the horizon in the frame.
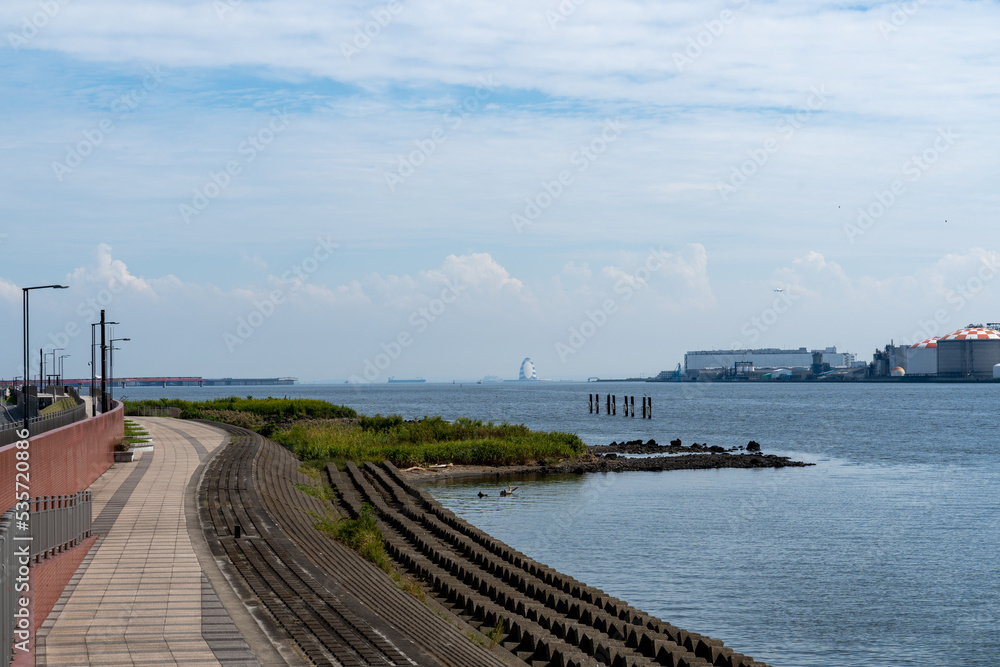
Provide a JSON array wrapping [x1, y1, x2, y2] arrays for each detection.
[[124, 383, 1000, 667]]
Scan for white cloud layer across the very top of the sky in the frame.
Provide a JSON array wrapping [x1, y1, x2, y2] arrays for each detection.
[[0, 0, 998, 118]]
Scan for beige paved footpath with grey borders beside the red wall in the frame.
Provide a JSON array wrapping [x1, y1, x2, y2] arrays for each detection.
[[36, 417, 287, 666]]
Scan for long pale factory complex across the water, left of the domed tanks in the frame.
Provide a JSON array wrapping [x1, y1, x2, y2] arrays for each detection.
[[684, 347, 866, 380]]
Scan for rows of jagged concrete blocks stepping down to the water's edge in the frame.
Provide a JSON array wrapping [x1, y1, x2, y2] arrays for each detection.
[[327, 463, 764, 667]]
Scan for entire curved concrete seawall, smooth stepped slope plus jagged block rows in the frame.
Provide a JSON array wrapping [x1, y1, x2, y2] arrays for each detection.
[[199, 426, 765, 667]]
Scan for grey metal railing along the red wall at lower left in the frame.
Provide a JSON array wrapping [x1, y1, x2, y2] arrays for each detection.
[[0, 491, 93, 667]]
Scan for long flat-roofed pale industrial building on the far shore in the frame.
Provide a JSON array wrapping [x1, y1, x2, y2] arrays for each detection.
[[684, 347, 855, 377]]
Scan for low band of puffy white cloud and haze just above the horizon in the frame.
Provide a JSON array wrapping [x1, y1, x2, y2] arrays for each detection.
[[0, 244, 1000, 379]]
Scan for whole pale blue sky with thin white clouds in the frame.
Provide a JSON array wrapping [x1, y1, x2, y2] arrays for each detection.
[[0, 0, 1000, 382]]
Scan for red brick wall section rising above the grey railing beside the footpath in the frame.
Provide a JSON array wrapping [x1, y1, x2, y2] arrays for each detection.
[[0, 403, 125, 512]]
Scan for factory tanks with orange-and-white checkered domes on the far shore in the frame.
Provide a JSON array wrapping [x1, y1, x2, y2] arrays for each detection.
[[869, 322, 1000, 380]]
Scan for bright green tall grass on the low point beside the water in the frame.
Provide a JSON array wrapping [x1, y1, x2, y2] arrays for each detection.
[[271, 415, 586, 467]]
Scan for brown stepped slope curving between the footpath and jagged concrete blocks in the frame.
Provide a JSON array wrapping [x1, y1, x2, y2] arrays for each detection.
[[197, 423, 518, 667]]
